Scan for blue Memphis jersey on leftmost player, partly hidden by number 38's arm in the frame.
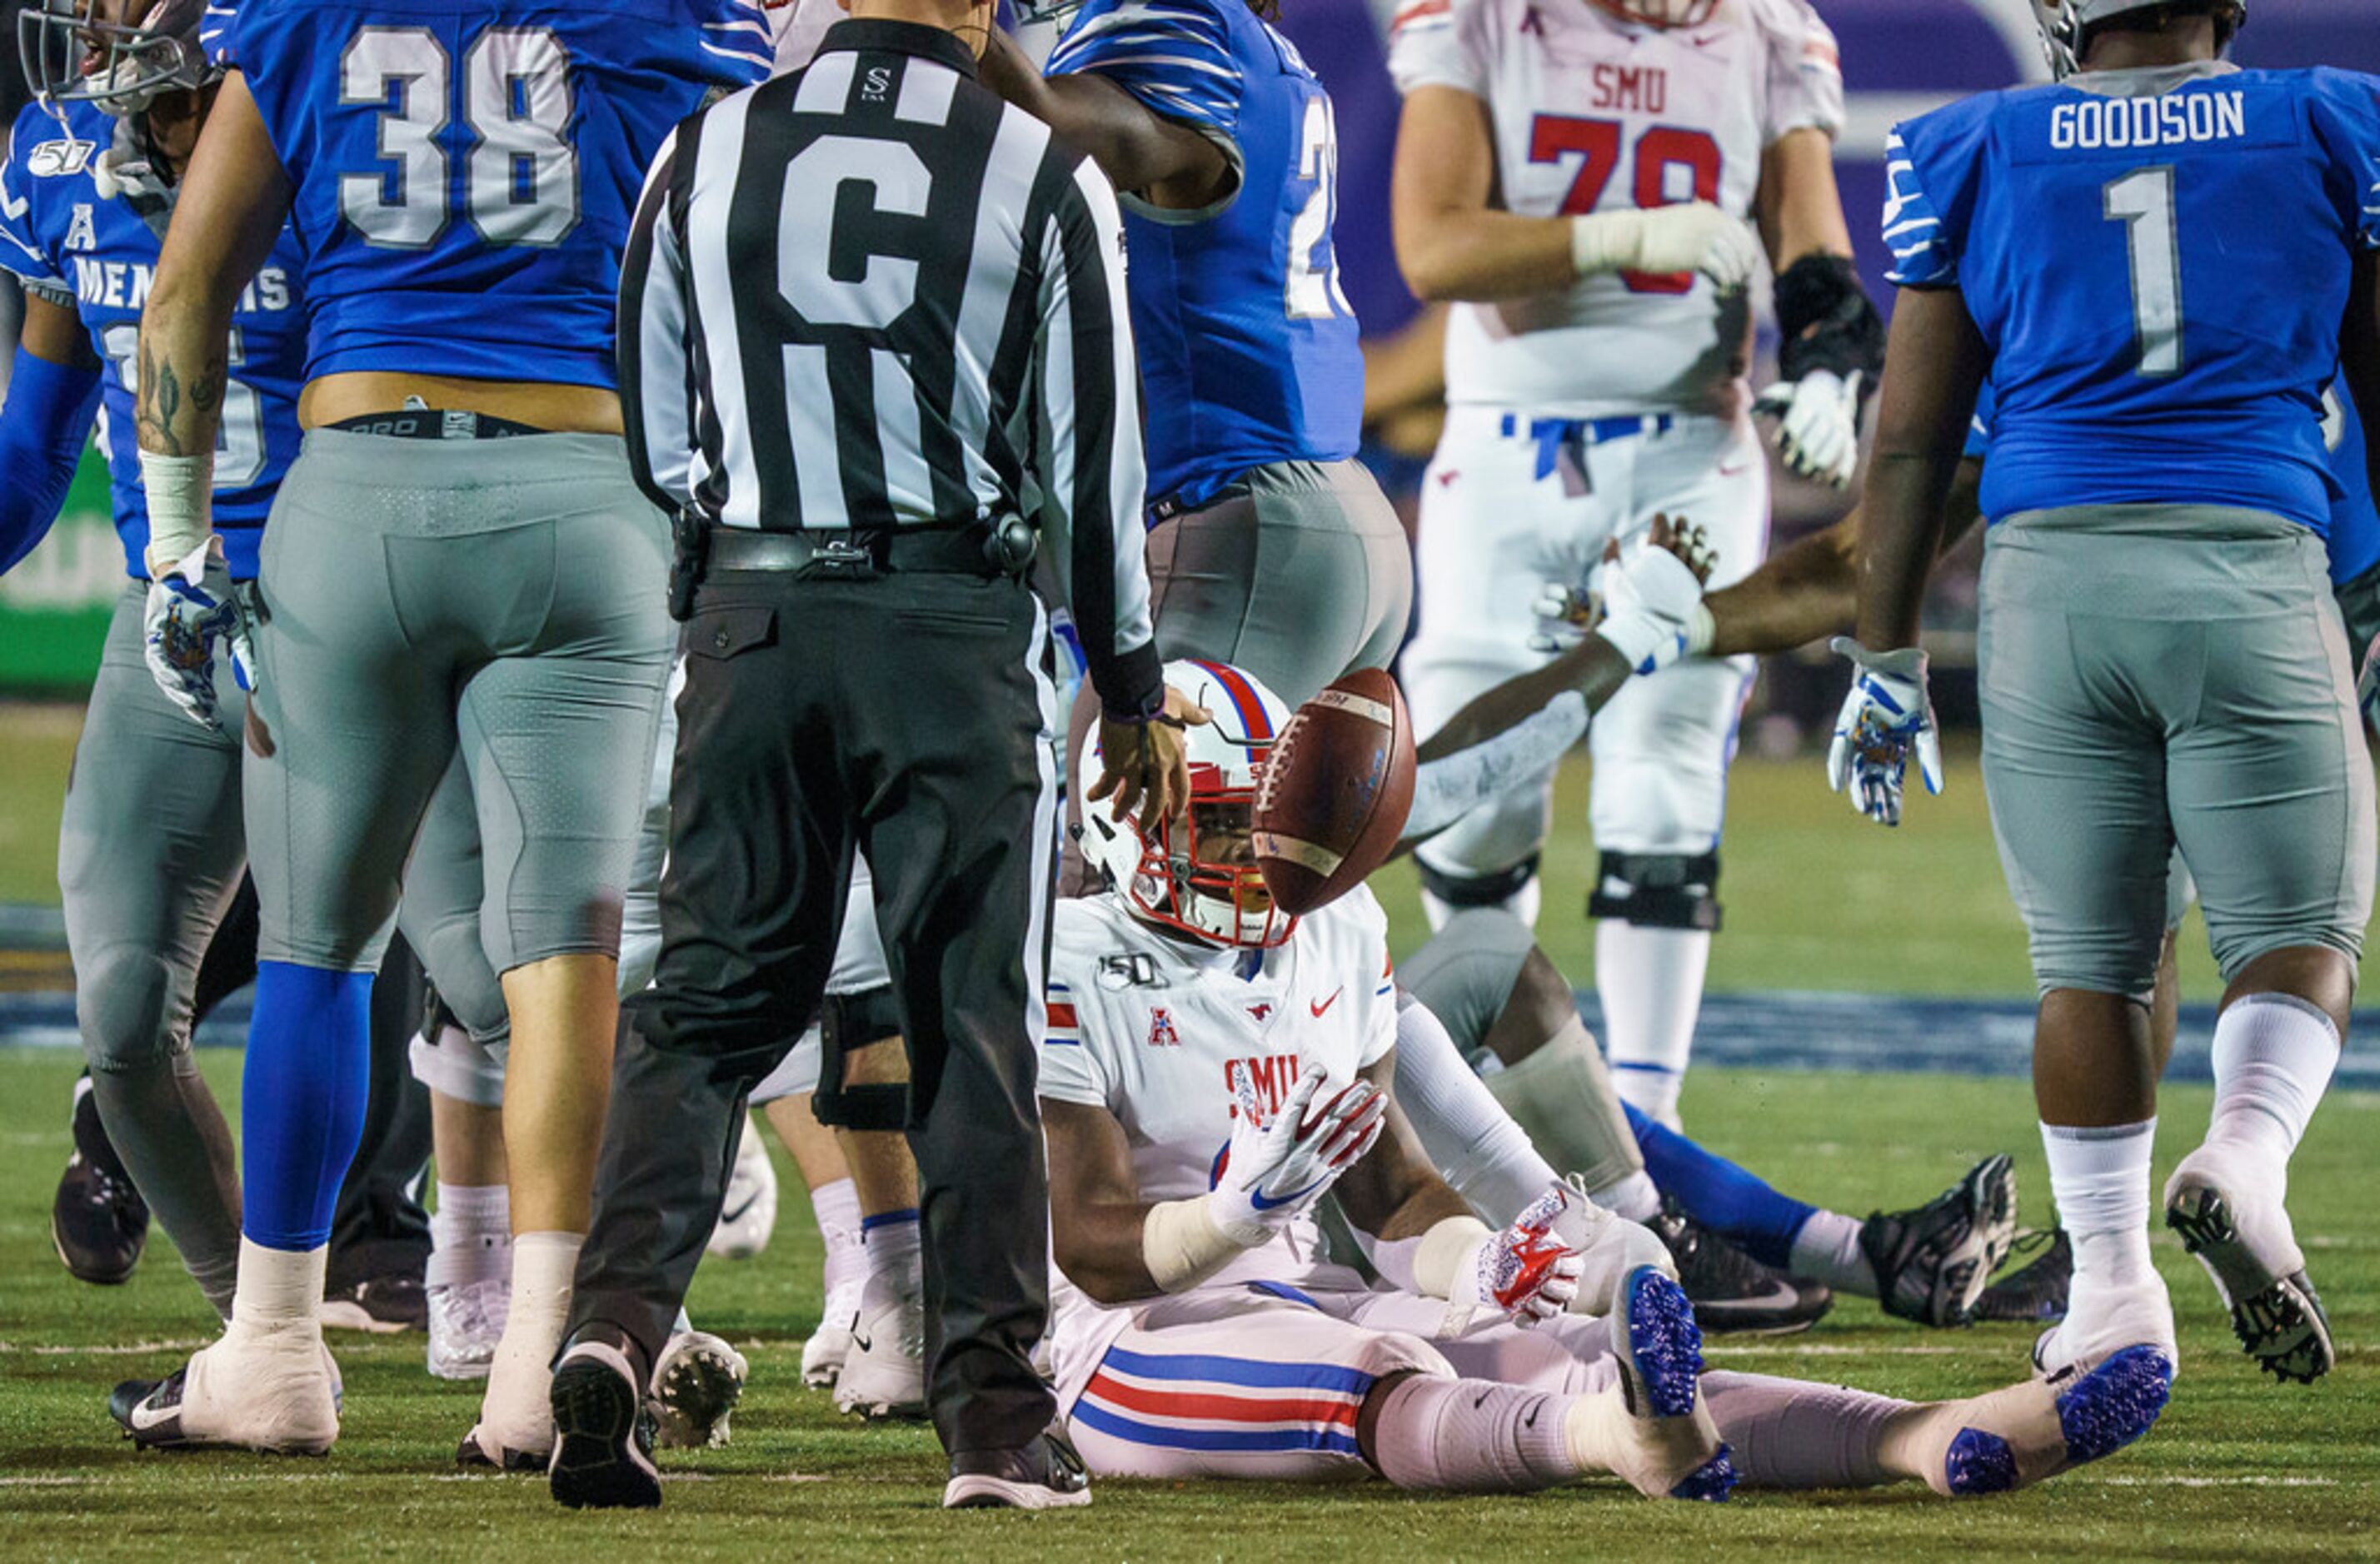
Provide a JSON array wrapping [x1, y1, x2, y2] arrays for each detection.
[[0, 102, 305, 580]]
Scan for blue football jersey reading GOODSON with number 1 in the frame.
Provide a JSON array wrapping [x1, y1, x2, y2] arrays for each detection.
[[1885, 64, 2380, 530]]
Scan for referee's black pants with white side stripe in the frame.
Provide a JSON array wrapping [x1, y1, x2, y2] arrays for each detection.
[[571, 571, 1057, 1455]]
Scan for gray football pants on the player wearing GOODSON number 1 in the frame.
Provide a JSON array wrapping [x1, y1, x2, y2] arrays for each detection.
[[1980, 505, 2375, 998]]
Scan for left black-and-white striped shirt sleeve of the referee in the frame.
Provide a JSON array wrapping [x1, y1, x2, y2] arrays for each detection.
[[619, 126, 695, 514]]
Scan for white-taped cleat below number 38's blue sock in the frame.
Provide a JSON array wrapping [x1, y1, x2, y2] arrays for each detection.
[[107, 1326, 341, 1455]]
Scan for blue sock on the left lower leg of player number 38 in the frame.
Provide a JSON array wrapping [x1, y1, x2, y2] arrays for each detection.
[[241, 962, 372, 1253]]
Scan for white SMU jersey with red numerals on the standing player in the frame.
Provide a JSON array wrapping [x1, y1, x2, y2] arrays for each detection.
[[1390, 0, 1842, 419]]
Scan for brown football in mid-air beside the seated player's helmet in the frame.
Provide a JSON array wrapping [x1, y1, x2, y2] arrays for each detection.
[[1255, 669, 1414, 917]]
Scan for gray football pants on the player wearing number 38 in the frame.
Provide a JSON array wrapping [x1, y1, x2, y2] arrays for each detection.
[[247, 429, 671, 979]]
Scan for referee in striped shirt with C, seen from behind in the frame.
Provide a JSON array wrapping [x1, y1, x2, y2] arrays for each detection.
[[552, 0, 1188, 1509]]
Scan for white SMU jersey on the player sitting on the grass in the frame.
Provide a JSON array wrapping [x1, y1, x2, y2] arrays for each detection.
[[1040, 888, 1397, 1378]]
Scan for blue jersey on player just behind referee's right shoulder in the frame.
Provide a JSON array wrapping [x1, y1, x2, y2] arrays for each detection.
[[1047, 0, 1364, 505]]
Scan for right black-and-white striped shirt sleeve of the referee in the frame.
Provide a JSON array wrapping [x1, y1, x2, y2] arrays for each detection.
[[1033, 157, 1164, 721]]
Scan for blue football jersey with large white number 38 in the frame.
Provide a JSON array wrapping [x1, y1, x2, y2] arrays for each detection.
[[207, 0, 771, 388]]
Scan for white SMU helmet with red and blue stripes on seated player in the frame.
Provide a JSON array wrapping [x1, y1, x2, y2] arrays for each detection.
[[1083, 660, 1297, 948]]
